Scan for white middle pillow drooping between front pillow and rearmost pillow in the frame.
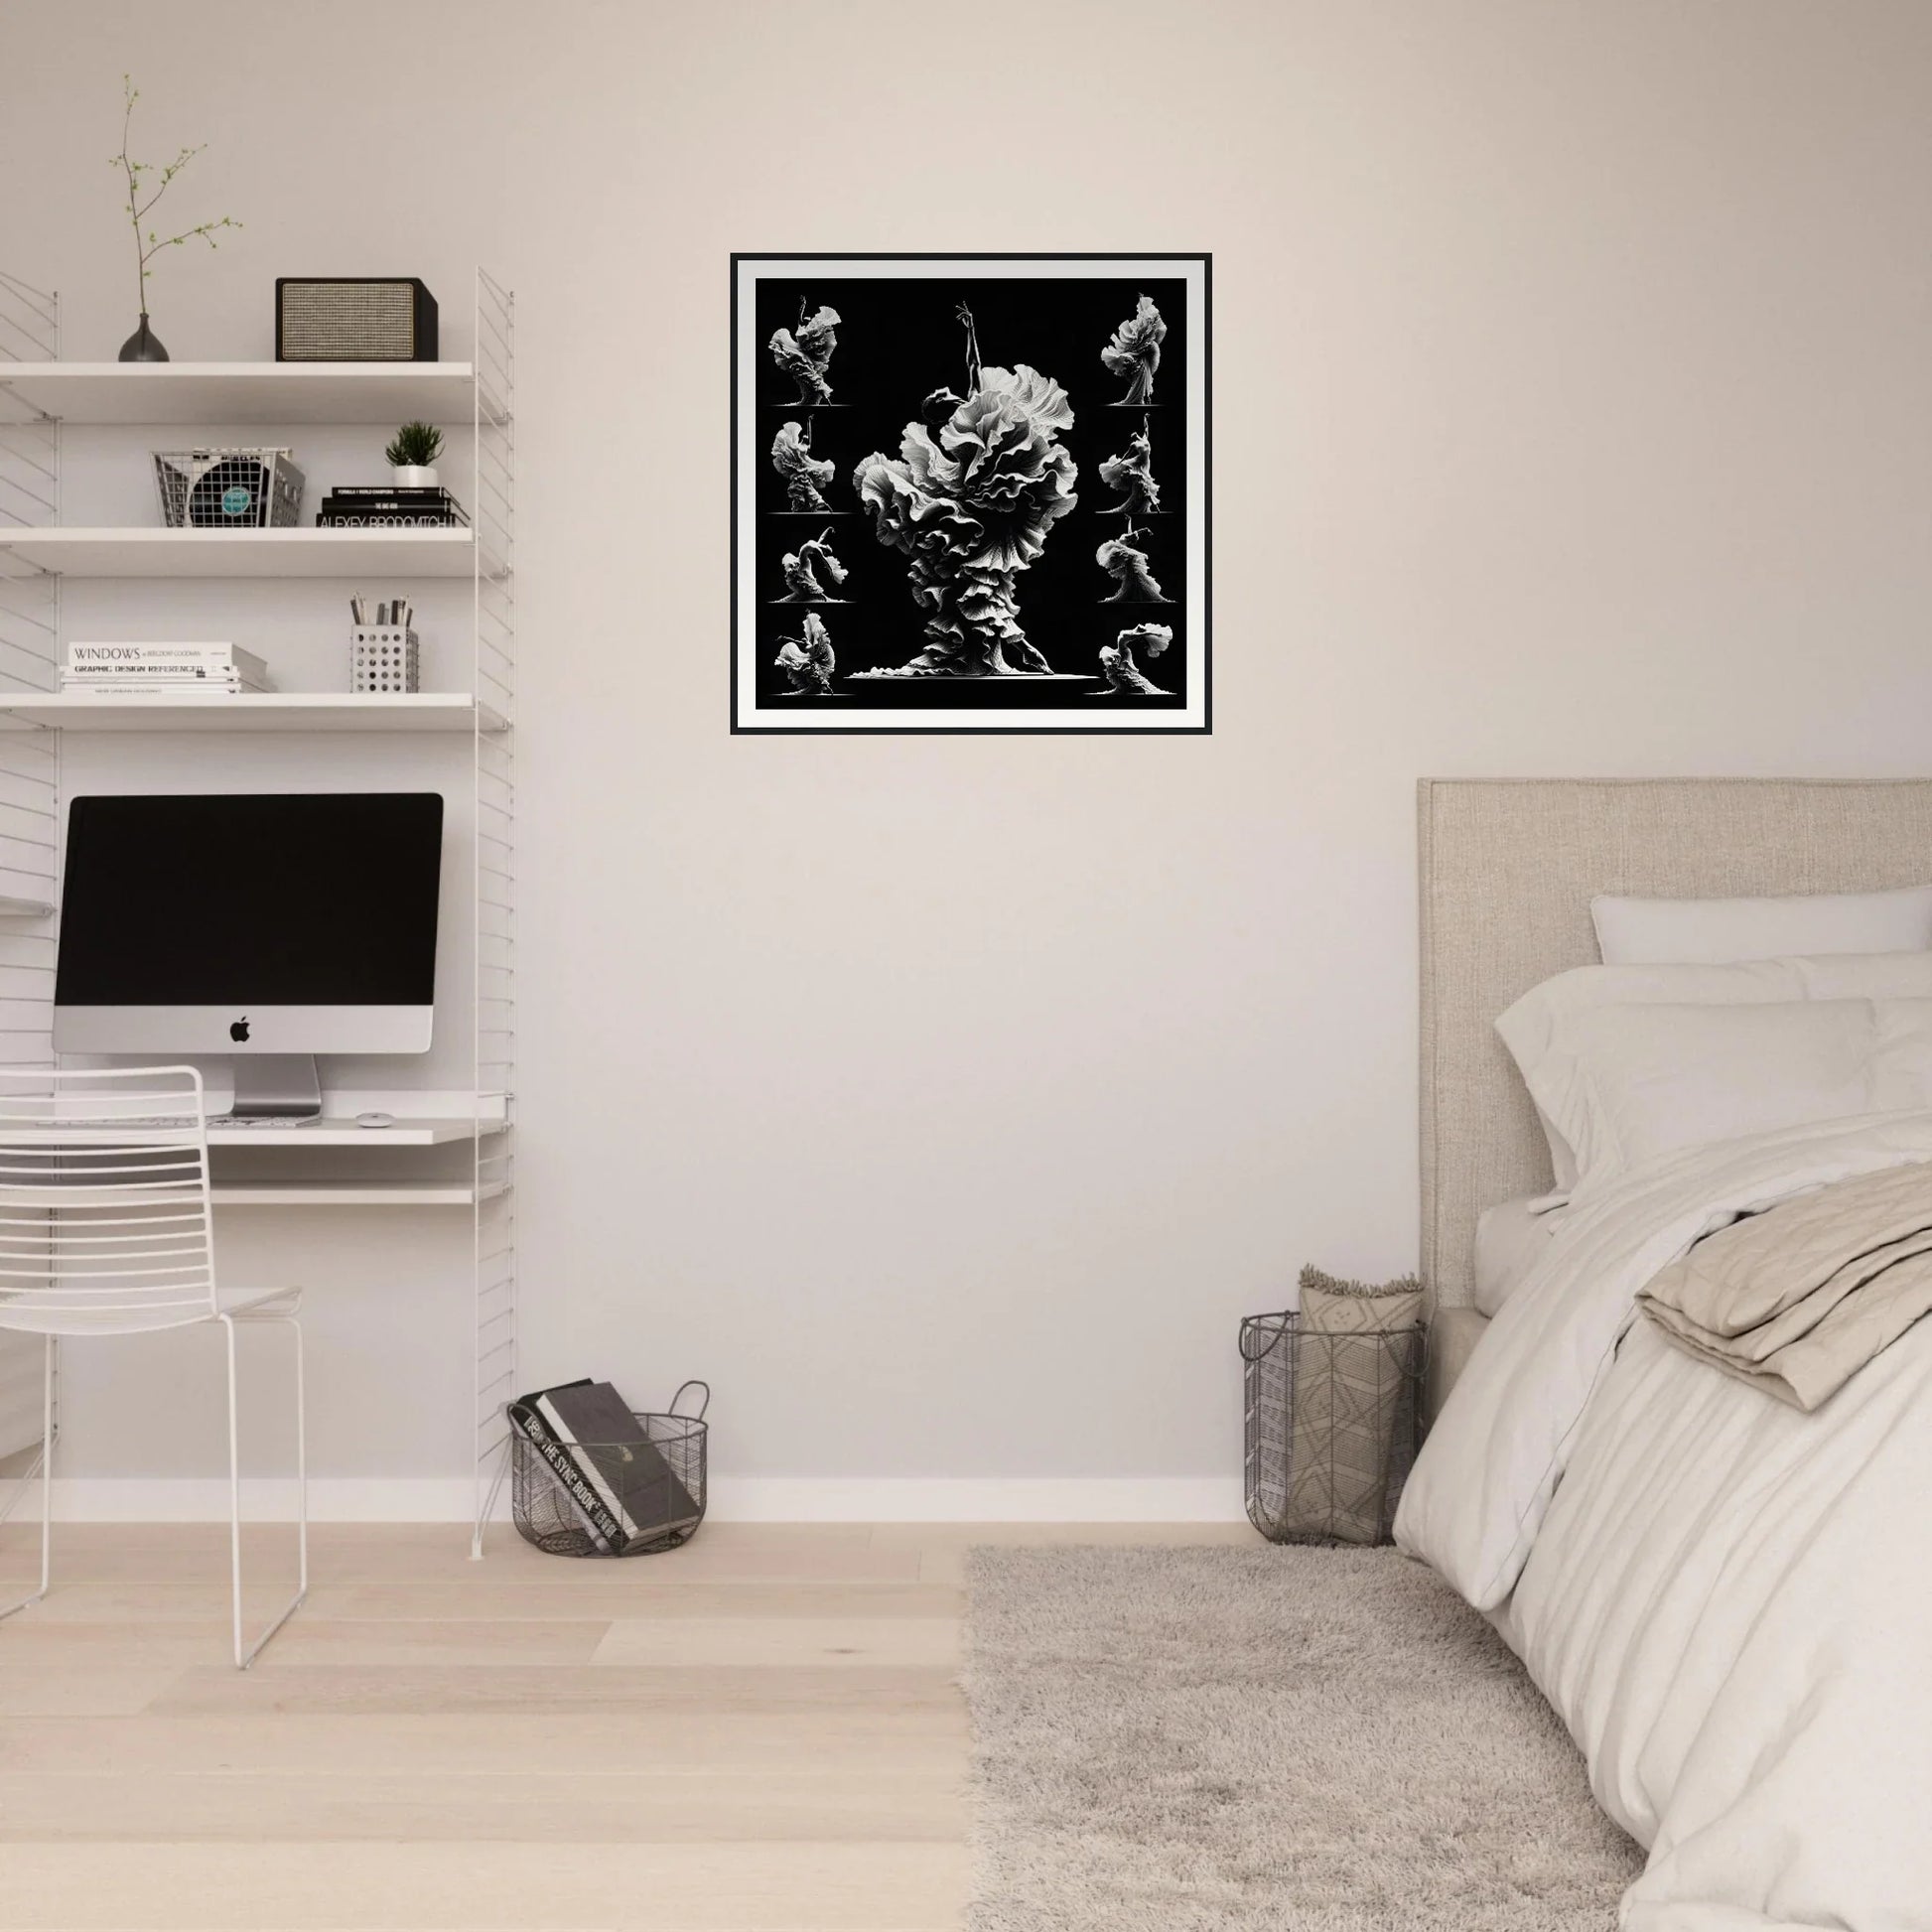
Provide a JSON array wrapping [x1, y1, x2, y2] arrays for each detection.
[[1495, 952, 1932, 1198]]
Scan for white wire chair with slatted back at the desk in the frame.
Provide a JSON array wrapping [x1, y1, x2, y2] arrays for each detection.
[[0, 1066, 309, 1669]]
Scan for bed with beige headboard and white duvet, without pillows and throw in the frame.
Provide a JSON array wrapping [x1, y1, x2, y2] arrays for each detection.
[[1397, 780, 1932, 1932]]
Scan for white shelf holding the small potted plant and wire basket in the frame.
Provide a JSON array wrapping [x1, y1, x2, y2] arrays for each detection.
[[0, 525, 476, 578]]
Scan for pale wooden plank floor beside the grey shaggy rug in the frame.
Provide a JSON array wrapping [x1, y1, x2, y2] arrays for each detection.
[[0, 1524, 1252, 1932]]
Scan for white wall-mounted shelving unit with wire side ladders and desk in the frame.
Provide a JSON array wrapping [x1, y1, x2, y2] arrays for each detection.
[[0, 268, 518, 1556]]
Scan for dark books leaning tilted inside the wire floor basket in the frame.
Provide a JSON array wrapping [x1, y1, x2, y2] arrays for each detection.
[[510, 1379, 703, 1556]]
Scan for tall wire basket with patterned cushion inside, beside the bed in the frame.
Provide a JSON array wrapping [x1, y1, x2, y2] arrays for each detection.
[[1240, 1308, 1422, 1544]]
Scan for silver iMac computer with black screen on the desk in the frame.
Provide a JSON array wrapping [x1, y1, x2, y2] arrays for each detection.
[[54, 792, 443, 1119]]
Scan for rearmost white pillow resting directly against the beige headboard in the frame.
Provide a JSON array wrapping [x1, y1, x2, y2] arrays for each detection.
[[1590, 885, 1932, 966]]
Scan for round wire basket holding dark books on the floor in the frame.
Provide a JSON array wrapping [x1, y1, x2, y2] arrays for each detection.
[[510, 1381, 711, 1557]]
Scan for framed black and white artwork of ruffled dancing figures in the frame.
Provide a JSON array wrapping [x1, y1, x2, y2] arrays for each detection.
[[733, 255, 1209, 733]]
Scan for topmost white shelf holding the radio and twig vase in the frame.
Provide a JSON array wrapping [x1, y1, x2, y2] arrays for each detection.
[[0, 361, 476, 427]]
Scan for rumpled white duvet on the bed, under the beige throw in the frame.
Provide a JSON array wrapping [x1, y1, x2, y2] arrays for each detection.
[[1395, 1115, 1932, 1932]]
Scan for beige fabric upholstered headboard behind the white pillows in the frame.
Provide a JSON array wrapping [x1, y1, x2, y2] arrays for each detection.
[[1418, 778, 1932, 1308]]
